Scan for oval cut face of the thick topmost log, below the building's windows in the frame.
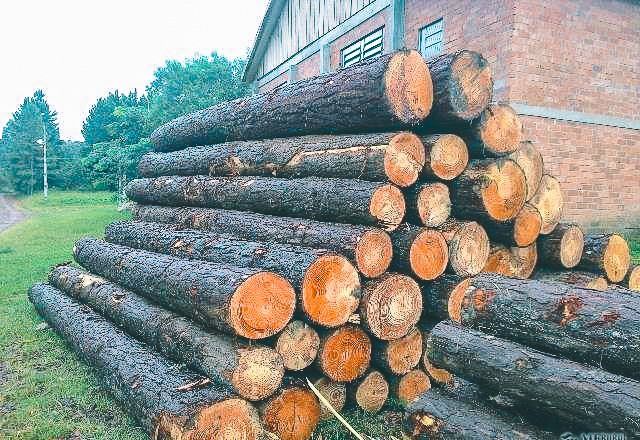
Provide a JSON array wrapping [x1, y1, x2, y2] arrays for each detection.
[[385, 50, 433, 125]]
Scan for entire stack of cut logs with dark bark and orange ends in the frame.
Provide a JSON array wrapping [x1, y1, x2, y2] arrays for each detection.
[[29, 50, 640, 440]]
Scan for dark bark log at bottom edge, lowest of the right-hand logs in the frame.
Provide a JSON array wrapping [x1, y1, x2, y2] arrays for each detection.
[[403, 388, 558, 440]]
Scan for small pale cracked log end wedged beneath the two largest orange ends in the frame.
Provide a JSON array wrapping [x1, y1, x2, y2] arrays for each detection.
[[274, 321, 320, 371]]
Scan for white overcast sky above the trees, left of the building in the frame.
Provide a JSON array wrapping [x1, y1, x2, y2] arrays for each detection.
[[0, 0, 268, 140]]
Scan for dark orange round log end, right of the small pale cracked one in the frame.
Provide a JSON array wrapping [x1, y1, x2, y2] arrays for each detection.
[[316, 324, 371, 382]]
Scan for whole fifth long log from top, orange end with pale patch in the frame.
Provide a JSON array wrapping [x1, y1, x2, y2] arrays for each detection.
[[105, 221, 361, 327]]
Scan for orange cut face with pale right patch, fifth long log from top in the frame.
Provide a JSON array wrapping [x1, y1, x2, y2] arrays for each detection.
[[301, 254, 361, 327]]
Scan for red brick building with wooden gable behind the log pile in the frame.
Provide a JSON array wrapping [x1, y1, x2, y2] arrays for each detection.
[[245, 0, 640, 228]]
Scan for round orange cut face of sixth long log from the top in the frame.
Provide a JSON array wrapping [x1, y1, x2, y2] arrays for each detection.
[[228, 272, 296, 339]]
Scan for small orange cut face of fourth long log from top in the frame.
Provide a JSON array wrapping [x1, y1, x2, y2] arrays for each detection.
[[355, 229, 393, 278]]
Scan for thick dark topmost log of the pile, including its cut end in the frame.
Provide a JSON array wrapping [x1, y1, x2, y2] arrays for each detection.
[[151, 50, 433, 151]]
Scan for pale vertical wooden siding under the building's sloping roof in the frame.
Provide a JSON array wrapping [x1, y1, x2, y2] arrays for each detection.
[[257, 0, 375, 78]]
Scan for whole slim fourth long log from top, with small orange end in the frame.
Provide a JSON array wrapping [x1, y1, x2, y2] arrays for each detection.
[[134, 205, 393, 278]]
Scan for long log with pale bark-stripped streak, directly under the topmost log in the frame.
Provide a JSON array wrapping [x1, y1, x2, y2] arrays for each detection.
[[139, 132, 425, 187]]
